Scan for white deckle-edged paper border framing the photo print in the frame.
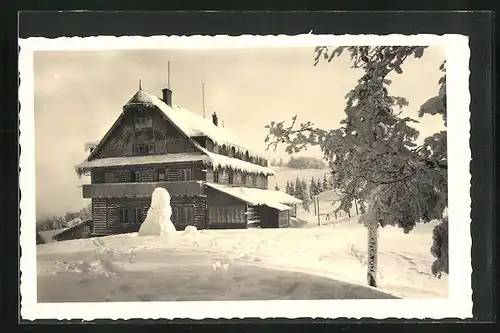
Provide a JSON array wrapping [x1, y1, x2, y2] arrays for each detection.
[[19, 33, 472, 320]]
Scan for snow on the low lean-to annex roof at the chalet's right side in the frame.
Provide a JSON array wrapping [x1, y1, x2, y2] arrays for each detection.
[[207, 183, 302, 210]]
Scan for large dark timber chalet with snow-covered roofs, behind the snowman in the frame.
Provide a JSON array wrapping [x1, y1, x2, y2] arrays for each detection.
[[76, 88, 300, 236]]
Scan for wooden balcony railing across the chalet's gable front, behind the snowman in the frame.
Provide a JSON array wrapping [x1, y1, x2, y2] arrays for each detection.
[[82, 181, 205, 199]]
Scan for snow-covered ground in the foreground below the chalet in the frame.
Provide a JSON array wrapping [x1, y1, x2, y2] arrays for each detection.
[[37, 213, 448, 302]]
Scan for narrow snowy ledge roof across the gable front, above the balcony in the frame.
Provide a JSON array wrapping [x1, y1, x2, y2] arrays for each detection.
[[75, 153, 208, 172]]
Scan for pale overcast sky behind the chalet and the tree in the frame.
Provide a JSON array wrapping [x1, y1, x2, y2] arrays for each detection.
[[34, 47, 444, 217]]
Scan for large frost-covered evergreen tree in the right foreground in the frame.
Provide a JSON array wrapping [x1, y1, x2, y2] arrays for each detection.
[[266, 46, 448, 286]]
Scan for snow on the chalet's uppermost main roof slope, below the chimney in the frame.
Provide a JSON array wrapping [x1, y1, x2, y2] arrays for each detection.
[[139, 90, 266, 159]]
